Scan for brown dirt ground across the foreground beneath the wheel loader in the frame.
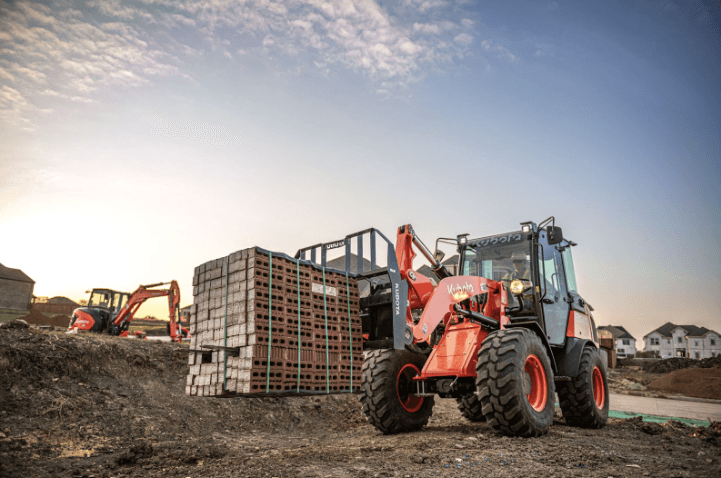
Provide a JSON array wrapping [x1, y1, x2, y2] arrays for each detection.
[[0, 329, 721, 478]]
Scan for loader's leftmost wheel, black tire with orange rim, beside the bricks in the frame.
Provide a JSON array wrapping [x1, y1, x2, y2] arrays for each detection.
[[360, 349, 434, 435]]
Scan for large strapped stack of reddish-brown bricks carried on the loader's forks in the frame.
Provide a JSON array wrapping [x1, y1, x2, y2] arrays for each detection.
[[186, 247, 363, 396]]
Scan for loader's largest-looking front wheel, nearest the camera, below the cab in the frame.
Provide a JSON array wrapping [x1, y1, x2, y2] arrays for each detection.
[[476, 329, 556, 437]]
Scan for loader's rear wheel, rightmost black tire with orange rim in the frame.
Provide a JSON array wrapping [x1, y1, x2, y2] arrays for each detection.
[[558, 347, 609, 428]]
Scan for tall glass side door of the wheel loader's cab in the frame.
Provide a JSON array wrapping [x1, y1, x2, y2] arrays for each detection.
[[538, 231, 571, 345]]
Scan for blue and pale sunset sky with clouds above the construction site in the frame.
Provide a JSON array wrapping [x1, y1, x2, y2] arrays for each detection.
[[0, 0, 721, 348]]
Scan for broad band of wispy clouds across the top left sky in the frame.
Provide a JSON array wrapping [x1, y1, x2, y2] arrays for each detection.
[[0, 0, 516, 127]]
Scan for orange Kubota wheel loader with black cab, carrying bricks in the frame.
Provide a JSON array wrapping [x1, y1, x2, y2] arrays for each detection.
[[296, 217, 609, 437]]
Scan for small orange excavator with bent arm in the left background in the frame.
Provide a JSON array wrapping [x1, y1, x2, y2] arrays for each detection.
[[68, 281, 190, 342]]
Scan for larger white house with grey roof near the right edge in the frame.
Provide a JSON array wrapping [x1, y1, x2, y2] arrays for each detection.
[[643, 322, 721, 359]]
